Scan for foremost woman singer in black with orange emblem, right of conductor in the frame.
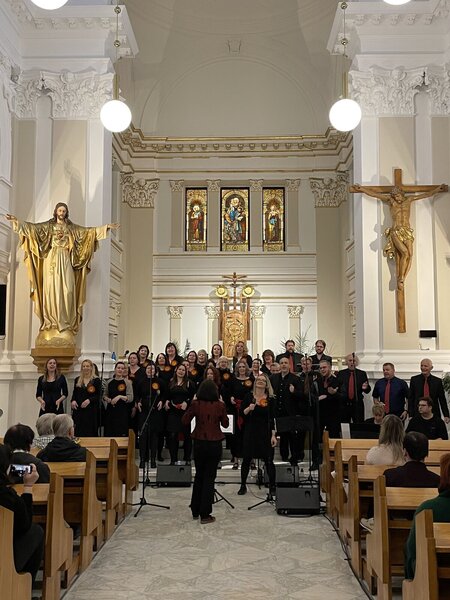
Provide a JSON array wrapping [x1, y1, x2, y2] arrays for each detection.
[[238, 374, 277, 496]]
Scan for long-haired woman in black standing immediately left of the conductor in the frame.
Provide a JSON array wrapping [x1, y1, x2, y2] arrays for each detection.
[[165, 365, 194, 465]]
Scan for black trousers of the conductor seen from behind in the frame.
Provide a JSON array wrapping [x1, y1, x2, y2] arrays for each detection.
[[190, 440, 222, 518]]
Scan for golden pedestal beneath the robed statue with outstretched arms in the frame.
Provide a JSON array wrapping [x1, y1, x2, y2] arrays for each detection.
[[31, 330, 81, 373]]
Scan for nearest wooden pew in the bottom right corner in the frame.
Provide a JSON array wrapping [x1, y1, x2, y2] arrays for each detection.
[[402, 509, 450, 600]]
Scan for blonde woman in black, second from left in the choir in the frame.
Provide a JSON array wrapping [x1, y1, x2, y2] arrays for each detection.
[[71, 359, 102, 437]]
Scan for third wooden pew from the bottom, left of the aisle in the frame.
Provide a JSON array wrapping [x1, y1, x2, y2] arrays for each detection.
[[47, 451, 103, 582]]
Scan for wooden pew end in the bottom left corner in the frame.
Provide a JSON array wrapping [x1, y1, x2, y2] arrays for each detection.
[[0, 506, 31, 600]]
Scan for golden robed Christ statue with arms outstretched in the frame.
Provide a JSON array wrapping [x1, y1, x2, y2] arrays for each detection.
[[6, 202, 119, 346]]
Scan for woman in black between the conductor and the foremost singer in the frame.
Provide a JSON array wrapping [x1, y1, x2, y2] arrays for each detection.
[[230, 360, 253, 469]]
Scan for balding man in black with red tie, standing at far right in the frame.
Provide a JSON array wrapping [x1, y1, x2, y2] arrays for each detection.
[[408, 358, 450, 423]]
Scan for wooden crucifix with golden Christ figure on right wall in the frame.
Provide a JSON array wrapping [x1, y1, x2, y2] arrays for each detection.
[[349, 169, 448, 333]]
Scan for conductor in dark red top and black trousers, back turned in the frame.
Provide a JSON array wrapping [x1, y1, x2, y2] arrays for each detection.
[[182, 379, 228, 524]]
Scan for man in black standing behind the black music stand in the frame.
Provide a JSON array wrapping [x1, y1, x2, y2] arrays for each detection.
[[270, 356, 301, 464]]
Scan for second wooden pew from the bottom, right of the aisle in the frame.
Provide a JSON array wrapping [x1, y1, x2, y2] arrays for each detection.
[[366, 477, 437, 600]]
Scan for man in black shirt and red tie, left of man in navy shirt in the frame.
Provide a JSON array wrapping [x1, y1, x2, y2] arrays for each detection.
[[337, 352, 371, 423]]
